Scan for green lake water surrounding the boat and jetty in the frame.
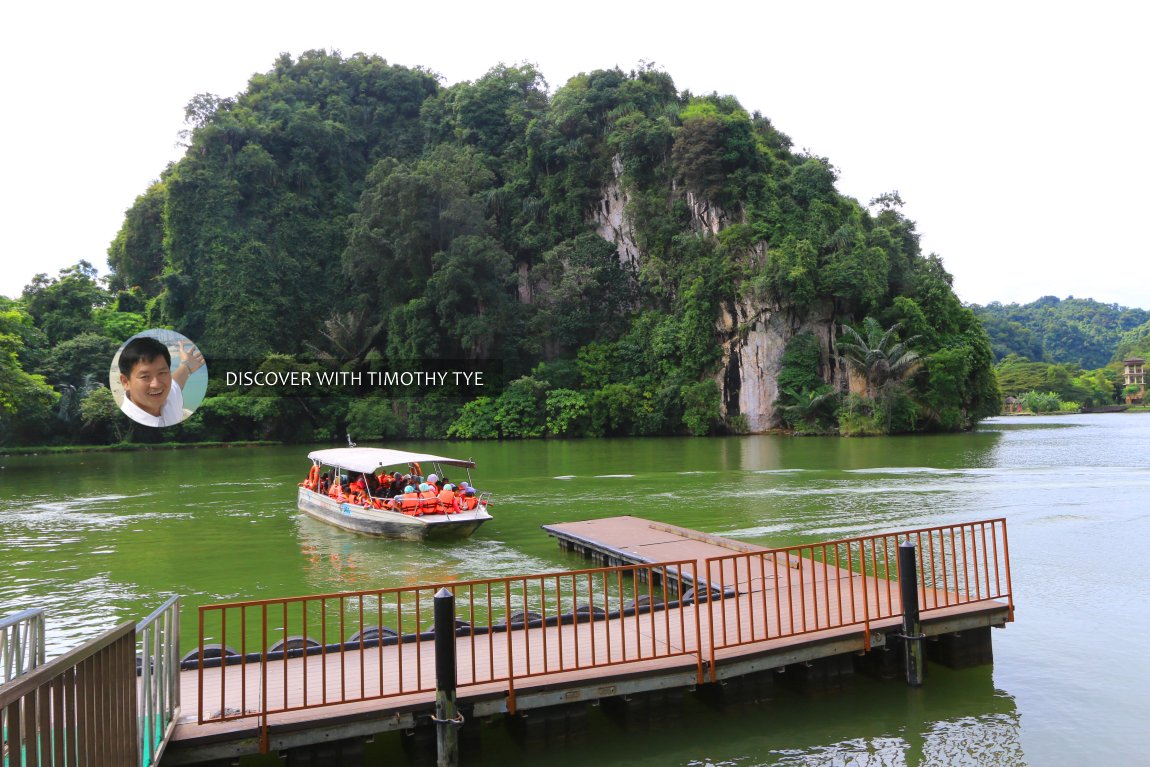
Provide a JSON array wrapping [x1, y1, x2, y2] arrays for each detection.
[[0, 415, 1150, 767]]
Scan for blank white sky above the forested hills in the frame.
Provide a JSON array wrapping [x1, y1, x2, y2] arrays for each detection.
[[0, 0, 1150, 308]]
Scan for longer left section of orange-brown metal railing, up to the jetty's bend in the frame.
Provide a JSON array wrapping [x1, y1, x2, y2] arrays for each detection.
[[185, 561, 703, 723]]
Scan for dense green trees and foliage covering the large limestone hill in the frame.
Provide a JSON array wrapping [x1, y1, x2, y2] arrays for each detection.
[[0, 52, 999, 442]]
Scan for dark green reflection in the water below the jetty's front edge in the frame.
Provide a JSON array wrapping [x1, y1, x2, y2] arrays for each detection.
[[466, 667, 1027, 767]]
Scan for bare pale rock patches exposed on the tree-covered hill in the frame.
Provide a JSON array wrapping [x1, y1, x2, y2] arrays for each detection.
[[592, 156, 845, 432]]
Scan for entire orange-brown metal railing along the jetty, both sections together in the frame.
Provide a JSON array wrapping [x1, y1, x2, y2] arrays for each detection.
[[193, 519, 1013, 728]]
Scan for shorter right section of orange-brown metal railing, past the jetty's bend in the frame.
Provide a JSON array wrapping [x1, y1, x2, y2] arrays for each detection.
[[704, 519, 1014, 673]]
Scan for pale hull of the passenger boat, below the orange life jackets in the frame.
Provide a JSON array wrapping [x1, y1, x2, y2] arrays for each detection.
[[298, 488, 491, 540]]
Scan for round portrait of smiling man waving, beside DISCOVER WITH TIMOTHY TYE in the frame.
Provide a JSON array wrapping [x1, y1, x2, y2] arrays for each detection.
[[108, 328, 208, 427]]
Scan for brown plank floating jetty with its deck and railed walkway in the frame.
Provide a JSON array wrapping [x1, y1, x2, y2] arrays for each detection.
[[164, 516, 1013, 764]]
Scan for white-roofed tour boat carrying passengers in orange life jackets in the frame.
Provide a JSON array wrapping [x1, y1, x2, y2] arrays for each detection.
[[298, 447, 491, 540]]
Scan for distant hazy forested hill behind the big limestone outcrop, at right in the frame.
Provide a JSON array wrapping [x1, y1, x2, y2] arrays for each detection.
[[971, 296, 1150, 370]]
